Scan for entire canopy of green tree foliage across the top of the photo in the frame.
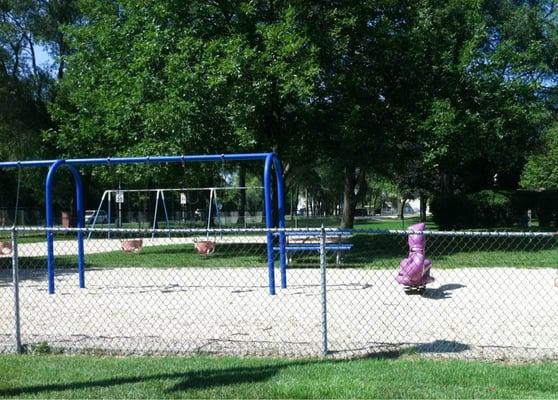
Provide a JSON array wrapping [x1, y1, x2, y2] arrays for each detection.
[[0, 0, 558, 226]]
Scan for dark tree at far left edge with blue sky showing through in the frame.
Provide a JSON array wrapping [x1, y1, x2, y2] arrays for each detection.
[[0, 0, 51, 211]]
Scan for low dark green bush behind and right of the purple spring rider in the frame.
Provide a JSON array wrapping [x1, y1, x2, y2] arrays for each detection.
[[430, 190, 517, 230]]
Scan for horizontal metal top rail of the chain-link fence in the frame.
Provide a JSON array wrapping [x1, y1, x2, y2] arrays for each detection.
[[0, 226, 558, 237]]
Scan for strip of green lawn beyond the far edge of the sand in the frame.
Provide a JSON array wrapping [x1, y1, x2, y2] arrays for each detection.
[[4, 234, 558, 269]]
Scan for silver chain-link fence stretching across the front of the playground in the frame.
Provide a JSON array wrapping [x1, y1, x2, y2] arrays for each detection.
[[0, 228, 558, 360]]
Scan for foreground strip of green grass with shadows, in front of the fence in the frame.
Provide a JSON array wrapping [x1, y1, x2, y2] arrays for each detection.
[[0, 355, 558, 399]]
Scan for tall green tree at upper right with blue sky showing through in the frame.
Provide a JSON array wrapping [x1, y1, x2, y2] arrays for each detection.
[[414, 1, 555, 193]]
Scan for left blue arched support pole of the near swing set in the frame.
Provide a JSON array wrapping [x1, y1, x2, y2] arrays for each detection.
[[45, 160, 85, 294]]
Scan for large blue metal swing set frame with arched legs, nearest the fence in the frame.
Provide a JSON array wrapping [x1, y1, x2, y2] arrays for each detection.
[[0, 153, 287, 295]]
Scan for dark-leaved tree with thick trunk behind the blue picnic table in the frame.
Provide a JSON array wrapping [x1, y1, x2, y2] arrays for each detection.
[[300, 1, 422, 228]]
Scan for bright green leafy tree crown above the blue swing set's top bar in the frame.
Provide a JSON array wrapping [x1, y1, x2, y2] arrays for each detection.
[[49, 1, 317, 164]]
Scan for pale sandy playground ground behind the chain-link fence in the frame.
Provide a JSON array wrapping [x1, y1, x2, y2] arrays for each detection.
[[0, 267, 558, 360]]
